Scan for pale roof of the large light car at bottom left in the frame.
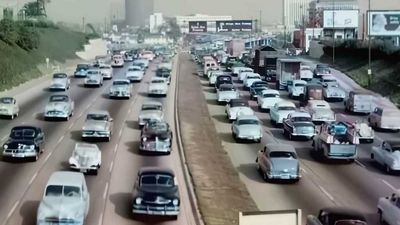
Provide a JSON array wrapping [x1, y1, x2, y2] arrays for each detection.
[[47, 171, 85, 187]]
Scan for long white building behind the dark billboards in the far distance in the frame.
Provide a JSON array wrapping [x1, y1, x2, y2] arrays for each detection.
[[175, 14, 232, 33]]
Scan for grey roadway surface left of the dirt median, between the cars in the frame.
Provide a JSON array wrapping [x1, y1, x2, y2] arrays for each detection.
[[0, 55, 195, 225]]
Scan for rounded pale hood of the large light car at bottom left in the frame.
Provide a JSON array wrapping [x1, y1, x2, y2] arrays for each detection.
[[37, 197, 86, 221]]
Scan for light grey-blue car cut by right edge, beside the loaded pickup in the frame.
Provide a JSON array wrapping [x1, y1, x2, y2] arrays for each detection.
[[371, 140, 400, 173]]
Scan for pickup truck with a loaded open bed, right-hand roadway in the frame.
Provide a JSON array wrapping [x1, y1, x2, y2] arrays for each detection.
[[311, 121, 359, 162]]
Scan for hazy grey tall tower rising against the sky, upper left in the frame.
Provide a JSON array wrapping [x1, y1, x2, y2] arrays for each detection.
[[125, 0, 154, 26]]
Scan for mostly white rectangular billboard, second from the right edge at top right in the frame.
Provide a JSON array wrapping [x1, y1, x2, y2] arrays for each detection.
[[323, 10, 358, 28]]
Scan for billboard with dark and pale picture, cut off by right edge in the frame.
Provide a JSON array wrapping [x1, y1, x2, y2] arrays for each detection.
[[368, 10, 400, 36]]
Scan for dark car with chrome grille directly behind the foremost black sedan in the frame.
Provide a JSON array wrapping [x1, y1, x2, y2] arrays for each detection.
[[139, 120, 172, 154]]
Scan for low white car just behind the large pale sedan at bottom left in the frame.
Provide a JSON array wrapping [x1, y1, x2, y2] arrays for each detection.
[[68, 143, 101, 175]]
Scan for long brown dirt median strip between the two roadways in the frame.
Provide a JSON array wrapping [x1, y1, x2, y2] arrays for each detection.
[[178, 54, 258, 225]]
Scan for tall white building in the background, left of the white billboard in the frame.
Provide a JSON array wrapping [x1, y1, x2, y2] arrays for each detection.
[[282, 0, 312, 32]]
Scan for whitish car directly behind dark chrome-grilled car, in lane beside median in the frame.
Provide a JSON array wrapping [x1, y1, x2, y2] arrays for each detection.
[[139, 101, 164, 126]]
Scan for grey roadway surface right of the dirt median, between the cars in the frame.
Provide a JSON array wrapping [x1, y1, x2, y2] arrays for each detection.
[[182, 54, 400, 224]]
